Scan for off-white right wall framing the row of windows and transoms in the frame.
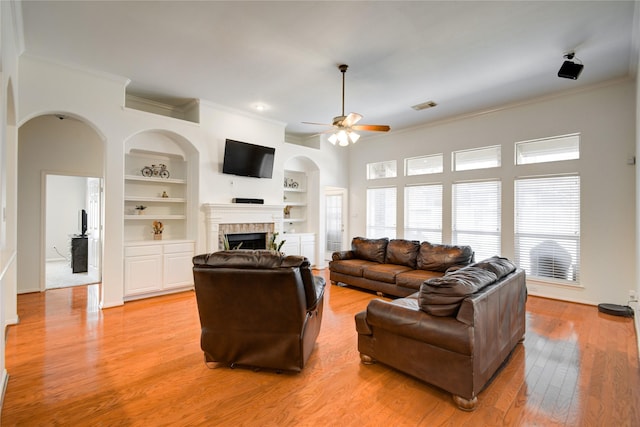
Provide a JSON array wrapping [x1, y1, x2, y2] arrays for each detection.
[[349, 81, 637, 304]]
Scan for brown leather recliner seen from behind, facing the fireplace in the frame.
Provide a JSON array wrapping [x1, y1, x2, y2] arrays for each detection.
[[193, 250, 325, 372]]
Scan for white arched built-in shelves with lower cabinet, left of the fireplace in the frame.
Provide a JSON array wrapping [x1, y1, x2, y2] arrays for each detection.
[[124, 142, 195, 300]]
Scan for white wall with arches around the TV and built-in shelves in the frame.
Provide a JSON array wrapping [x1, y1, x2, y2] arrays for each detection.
[[18, 56, 347, 307]]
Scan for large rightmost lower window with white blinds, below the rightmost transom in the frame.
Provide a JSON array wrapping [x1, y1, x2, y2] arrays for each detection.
[[515, 175, 580, 282]]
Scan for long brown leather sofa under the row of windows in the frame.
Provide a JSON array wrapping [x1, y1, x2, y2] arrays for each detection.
[[329, 237, 474, 297]]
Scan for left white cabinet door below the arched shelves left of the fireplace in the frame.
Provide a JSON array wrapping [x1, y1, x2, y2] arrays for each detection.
[[124, 255, 162, 295]]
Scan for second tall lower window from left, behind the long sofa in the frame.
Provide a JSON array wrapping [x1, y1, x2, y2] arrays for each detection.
[[404, 184, 442, 243]]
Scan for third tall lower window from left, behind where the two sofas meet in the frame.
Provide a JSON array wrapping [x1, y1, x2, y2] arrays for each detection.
[[452, 181, 501, 261]]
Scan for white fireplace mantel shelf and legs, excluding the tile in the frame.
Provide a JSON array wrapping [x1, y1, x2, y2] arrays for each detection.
[[202, 203, 284, 252]]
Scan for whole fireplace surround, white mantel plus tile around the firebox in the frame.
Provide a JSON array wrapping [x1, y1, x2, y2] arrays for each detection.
[[203, 203, 283, 252]]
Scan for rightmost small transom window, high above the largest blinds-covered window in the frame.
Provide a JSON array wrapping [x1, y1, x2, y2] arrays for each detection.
[[516, 133, 580, 165]]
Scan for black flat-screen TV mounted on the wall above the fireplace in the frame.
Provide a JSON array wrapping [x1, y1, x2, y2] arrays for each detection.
[[222, 139, 276, 178]]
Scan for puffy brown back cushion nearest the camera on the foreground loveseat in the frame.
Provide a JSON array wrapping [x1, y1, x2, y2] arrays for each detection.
[[418, 267, 497, 316]]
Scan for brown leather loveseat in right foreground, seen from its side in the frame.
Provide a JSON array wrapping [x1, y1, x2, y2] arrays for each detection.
[[355, 257, 527, 410]]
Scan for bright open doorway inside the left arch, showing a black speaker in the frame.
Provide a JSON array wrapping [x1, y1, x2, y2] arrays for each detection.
[[43, 173, 102, 289]]
